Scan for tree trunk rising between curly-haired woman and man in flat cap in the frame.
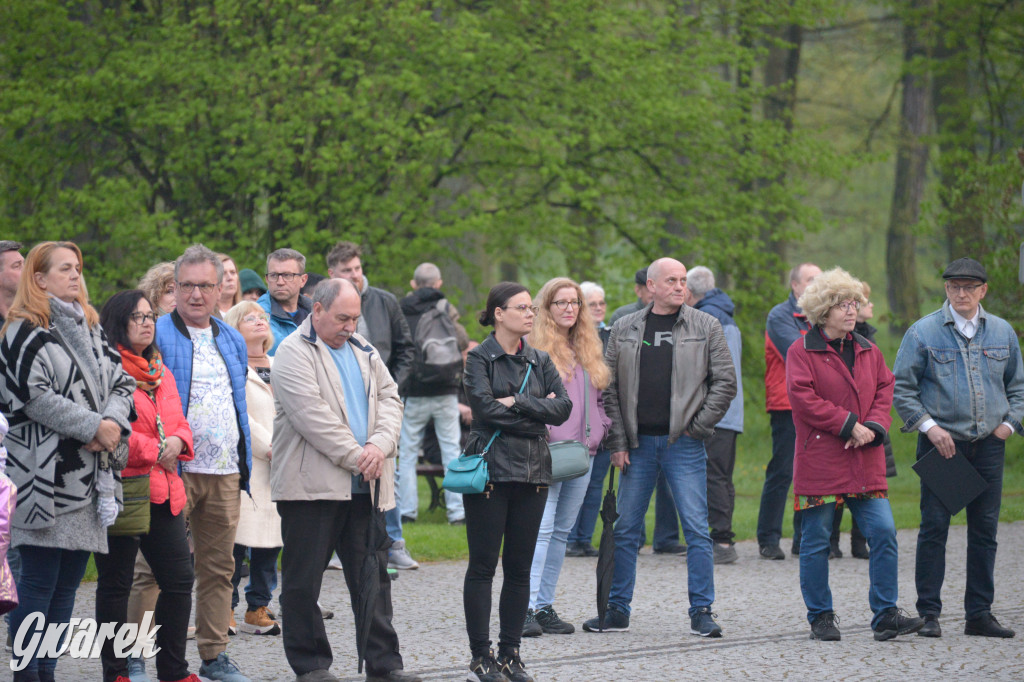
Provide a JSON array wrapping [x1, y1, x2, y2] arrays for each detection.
[[886, 6, 931, 334]]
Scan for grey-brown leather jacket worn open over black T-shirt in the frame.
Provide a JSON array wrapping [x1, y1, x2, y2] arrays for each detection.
[[603, 303, 736, 453]]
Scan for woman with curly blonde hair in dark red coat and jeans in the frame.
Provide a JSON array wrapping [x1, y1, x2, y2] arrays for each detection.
[[785, 267, 924, 641]]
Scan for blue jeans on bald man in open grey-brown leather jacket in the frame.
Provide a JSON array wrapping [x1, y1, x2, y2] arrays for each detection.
[[608, 435, 715, 615]]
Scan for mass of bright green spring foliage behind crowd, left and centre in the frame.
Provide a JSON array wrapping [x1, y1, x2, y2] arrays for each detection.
[[0, 0, 831, 309]]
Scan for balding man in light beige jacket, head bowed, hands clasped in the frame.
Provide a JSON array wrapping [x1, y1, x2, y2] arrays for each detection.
[[270, 280, 420, 682]]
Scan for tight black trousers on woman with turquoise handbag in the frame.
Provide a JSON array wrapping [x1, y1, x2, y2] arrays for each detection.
[[462, 483, 548, 656]]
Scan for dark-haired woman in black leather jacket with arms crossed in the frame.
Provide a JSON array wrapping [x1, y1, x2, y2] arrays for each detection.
[[463, 282, 572, 682]]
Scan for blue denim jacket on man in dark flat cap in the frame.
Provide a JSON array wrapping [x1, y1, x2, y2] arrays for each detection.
[[893, 301, 1024, 440]]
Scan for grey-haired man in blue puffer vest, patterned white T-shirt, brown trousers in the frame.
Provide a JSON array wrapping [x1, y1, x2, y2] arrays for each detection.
[[157, 244, 252, 682]]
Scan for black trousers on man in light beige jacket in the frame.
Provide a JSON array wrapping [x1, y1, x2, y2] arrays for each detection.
[[278, 495, 403, 676]]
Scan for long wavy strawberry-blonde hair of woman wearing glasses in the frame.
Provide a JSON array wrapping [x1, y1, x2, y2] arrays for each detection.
[[529, 278, 611, 390]]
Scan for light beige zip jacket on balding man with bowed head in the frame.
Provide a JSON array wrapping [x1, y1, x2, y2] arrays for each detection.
[[270, 315, 402, 503]]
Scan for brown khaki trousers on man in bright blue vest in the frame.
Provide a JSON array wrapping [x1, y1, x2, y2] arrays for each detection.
[[181, 472, 241, 660]]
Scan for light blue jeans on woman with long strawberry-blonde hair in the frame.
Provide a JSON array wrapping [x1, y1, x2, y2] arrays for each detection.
[[529, 458, 594, 608]]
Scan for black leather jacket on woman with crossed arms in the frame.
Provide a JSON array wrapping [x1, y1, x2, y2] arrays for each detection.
[[465, 333, 572, 485]]
